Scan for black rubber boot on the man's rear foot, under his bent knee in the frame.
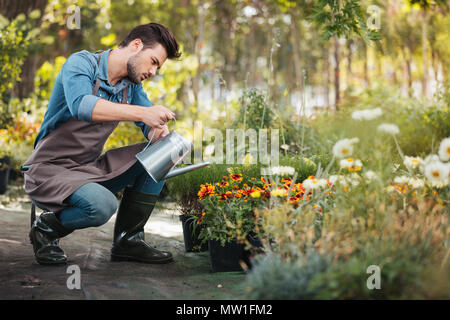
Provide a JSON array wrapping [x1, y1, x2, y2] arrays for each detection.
[[30, 212, 73, 265]]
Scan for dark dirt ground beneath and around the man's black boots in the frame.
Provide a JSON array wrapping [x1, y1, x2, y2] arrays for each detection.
[[0, 185, 246, 300]]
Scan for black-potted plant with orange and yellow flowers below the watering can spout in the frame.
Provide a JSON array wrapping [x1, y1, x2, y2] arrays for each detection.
[[195, 173, 270, 272]]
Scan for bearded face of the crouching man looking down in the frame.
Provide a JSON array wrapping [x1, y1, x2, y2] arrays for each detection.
[[127, 43, 167, 84]]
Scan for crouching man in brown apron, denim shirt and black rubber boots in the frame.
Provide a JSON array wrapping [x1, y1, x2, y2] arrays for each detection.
[[24, 23, 181, 264]]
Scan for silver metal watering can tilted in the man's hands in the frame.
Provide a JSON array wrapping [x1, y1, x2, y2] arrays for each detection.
[[136, 119, 210, 182]]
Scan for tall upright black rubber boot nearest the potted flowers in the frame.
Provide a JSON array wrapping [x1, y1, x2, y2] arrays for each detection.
[[111, 187, 173, 263]]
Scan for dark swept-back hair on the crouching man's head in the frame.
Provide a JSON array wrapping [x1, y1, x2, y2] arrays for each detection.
[[119, 22, 181, 59]]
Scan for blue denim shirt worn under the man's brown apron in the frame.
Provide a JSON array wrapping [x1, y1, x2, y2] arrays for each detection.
[[34, 49, 152, 147]]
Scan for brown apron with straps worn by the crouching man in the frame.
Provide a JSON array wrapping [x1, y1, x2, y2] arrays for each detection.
[[24, 54, 146, 212]]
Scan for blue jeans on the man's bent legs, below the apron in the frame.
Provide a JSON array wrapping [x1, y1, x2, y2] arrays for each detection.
[[58, 161, 165, 229]]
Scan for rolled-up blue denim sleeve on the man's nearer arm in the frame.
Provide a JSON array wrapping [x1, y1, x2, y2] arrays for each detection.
[[61, 54, 100, 122]]
